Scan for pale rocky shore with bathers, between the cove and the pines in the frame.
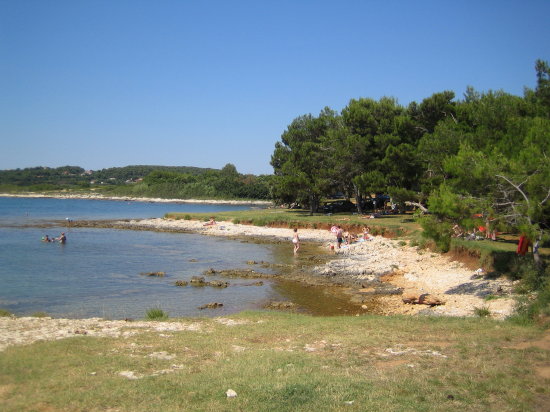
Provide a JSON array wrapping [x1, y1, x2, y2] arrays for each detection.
[[113, 218, 515, 319]]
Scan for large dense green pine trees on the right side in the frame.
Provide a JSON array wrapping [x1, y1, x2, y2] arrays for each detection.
[[271, 60, 550, 260]]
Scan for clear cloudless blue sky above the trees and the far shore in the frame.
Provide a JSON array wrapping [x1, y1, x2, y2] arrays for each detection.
[[0, 0, 550, 174]]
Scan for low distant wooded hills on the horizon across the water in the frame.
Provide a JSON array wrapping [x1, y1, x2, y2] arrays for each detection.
[[0, 164, 270, 199]]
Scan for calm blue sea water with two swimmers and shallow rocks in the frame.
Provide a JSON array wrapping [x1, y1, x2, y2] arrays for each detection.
[[0, 197, 336, 319]]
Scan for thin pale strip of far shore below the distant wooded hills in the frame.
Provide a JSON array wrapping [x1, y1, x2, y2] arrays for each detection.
[[0, 193, 273, 206]]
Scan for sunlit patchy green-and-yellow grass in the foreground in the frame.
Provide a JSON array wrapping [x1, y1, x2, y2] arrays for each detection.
[[0, 312, 550, 411]]
